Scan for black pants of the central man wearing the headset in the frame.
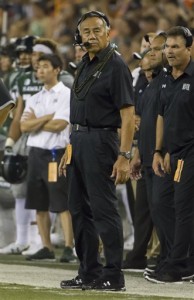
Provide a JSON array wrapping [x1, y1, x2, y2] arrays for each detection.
[[67, 131, 123, 281]]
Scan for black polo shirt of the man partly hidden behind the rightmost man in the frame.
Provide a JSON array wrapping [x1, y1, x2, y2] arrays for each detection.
[[138, 70, 165, 167]]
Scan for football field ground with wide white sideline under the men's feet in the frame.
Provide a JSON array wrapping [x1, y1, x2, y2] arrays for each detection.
[[0, 249, 194, 300]]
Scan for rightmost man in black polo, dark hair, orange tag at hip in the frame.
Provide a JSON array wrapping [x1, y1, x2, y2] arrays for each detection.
[[152, 26, 194, 282]]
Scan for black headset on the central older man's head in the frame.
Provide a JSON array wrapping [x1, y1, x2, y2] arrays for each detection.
[[74, 10, 110, 46]]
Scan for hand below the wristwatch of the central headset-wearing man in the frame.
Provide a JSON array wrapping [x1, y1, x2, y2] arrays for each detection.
[[111, 156, 130, 185]]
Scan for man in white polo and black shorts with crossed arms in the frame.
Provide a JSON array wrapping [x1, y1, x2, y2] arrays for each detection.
[[21, 54, 73, 260]]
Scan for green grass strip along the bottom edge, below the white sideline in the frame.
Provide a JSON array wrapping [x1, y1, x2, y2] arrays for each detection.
[[0, 283, 189, 300]]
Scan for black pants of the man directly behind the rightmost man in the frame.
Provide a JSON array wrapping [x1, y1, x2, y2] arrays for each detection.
[[144, 167, 175, 260]]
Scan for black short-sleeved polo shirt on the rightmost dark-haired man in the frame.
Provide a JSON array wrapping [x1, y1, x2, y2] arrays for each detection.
[[159, 61, 194, 158]]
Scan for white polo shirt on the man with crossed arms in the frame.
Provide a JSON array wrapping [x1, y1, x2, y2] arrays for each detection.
[[24, 82, 70, 150]]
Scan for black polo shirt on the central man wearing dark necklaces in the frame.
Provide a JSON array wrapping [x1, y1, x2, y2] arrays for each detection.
[[70, 45, 134, 128]]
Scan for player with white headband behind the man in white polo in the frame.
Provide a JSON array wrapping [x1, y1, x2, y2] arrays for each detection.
[[0, 38, 73, 255]]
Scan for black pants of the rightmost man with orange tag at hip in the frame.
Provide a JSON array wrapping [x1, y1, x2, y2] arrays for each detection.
[[170, 151, 194, 269]]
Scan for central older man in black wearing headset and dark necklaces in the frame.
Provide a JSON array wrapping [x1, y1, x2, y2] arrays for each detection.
[[59, 11, 134, 290]]
